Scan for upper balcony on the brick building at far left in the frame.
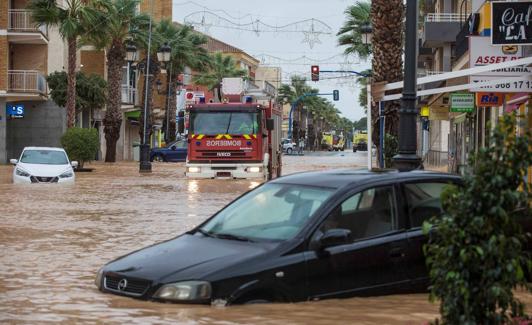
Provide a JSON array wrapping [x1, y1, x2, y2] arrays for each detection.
[[7, 9, 48, 44]]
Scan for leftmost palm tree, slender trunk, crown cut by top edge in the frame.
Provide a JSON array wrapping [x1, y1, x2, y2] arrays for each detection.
[[27, 0, 102, 128]]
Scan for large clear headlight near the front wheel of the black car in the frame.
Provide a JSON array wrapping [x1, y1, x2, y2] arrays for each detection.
[[153, 281, 211, 301]]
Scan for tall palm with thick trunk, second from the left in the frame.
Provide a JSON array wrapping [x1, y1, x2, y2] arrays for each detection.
[[88, 0, 150, 162]]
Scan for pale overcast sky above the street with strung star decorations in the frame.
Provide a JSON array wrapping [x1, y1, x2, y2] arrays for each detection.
[[173, 0, 370, 120]]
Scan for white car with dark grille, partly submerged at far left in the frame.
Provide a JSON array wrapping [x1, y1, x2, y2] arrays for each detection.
[[9, 147, 78, 184]]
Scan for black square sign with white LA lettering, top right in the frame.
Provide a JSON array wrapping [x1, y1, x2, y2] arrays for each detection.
[[491, 1, 532, 45]]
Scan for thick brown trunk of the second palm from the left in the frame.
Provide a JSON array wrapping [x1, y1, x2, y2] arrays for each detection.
[[103, 42, 125, 162]]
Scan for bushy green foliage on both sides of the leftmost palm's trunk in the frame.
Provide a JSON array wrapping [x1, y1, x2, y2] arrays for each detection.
[[46, 71, 107, 110]]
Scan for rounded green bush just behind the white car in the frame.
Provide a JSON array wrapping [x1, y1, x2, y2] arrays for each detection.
[[61, 128, 100, 168]]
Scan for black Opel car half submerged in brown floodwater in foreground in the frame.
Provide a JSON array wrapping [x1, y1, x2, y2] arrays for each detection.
[[96, 170, 532, 304]]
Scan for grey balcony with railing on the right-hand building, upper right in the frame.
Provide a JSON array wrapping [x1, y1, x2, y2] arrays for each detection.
[[422, 13, 467, 48]]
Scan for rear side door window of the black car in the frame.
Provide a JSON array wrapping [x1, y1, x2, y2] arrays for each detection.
[[404, 183, 447, 228]]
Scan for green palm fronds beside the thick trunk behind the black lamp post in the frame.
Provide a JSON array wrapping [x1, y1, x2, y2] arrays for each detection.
[[336, 1, 371, 59]]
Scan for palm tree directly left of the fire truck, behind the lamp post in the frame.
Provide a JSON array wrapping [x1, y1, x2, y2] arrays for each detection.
[[158, 20, 211, 143]]
